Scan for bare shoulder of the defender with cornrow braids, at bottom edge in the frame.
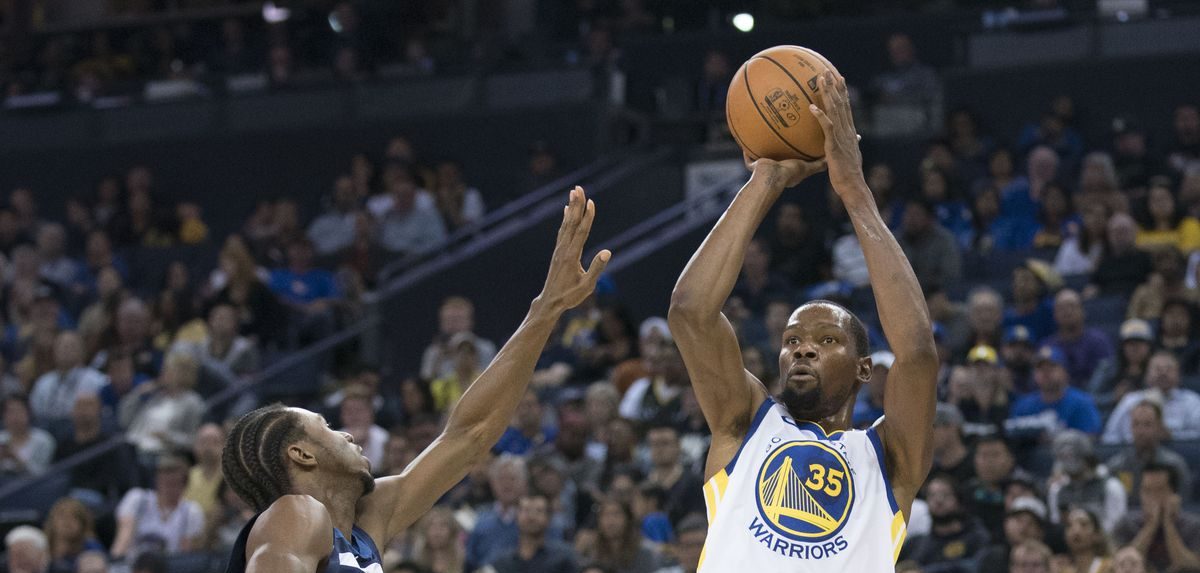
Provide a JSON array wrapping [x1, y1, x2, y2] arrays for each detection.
[[246, 495, 334, 573]]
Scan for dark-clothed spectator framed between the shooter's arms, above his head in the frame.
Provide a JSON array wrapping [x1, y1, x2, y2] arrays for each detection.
[[763, 201, 832, 288]]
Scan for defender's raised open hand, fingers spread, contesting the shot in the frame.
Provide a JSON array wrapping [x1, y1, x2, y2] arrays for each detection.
[[539, 187, 612, 312]]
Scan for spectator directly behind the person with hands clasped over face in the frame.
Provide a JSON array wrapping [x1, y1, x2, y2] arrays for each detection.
[[1104, 400, 1192, 505]]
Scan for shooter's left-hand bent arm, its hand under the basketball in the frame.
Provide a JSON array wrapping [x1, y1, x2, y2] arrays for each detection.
[[667, 155, 824, 479]]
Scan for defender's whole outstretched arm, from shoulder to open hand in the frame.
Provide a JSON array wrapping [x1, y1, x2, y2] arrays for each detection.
[[358, 187, 611, 544]]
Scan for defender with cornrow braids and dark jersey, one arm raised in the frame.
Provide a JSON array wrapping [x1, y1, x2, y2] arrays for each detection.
[[222, 187, 611, 573]]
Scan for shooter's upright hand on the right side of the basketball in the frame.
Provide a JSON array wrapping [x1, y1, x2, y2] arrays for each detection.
[[809, 72, 863, 190]]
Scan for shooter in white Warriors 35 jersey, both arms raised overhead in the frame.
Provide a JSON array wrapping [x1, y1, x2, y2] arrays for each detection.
[[670, 72, 937, 573]]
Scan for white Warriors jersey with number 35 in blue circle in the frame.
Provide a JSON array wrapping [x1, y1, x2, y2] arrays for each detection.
[[700, 398, 905, 573]]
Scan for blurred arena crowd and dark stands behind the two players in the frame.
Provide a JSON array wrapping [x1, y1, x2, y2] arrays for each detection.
[[0, 0, 1200, 573]]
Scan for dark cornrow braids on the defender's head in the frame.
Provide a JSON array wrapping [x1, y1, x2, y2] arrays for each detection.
[[221, 404, 304, 512]]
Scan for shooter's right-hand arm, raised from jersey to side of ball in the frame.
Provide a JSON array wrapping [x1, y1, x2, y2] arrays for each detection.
[[810, 72, 938, 515]]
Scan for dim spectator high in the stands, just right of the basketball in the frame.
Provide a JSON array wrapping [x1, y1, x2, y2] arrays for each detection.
[[871, 34, 942, 132]]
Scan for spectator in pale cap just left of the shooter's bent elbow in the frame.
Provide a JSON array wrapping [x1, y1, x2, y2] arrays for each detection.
[[618, 338, 690, 423]]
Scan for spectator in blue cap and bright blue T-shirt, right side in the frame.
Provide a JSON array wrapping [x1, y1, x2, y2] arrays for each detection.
[[1006, 345, 1102, 435]]
